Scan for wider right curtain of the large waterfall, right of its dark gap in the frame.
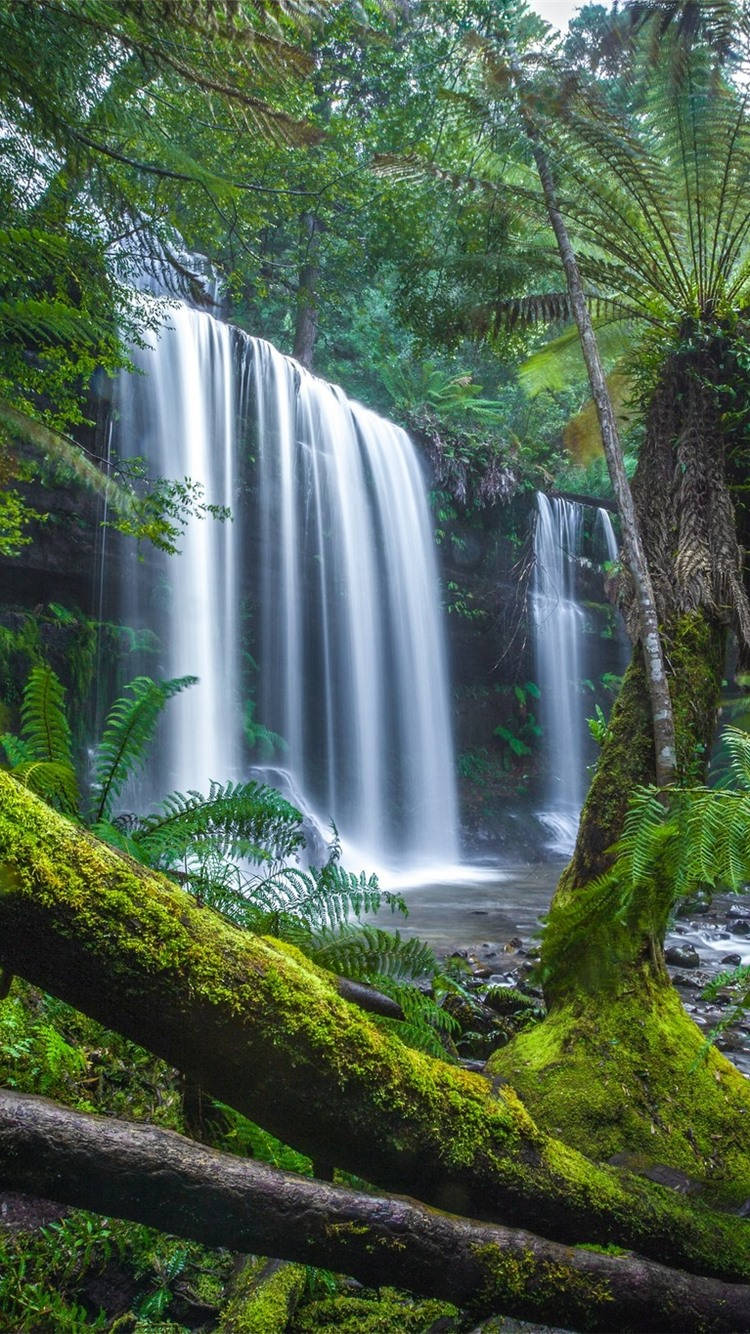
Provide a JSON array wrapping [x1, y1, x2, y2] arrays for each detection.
[[254, 340, 458, 864]]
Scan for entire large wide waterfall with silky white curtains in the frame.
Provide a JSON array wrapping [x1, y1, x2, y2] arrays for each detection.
[[114, 304, 458, 866]]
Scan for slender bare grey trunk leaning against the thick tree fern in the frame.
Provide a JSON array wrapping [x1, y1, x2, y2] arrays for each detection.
[[514, 80, 677, 787]]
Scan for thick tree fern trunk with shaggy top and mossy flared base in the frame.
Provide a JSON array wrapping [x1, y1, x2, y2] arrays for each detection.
[[491, 356, 750, 1178]]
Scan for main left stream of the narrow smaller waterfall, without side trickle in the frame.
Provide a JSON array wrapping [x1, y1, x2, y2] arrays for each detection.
[[531, 492, 586, 852]]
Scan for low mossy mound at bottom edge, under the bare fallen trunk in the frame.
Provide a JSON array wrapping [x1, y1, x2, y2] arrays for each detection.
[[290, 1287, 460, 1334]]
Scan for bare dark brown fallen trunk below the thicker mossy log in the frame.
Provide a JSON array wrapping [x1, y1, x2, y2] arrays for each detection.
[[0, 1090, 750, 1334]]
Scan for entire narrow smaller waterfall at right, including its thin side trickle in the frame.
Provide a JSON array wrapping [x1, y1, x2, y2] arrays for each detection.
[[531, 492, 627, 855]]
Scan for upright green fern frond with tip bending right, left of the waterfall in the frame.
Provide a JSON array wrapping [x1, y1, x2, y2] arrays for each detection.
[[91, 676, 198, 823]]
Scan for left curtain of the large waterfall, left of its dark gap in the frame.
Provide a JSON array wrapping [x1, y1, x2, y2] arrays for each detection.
[[117, 304, 240, 800]]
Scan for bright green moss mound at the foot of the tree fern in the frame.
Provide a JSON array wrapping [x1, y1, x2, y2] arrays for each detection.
[[490, 983, 750, 1198]]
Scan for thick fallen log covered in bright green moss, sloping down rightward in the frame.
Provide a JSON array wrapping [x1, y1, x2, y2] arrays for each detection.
[[0, 774, 750, 1282]]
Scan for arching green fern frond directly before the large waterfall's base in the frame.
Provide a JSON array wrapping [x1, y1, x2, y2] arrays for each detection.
[[135, 782, 304, 866]]
